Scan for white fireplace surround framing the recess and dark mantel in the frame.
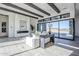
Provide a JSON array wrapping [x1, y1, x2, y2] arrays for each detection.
[[14, 15, 30, 37]]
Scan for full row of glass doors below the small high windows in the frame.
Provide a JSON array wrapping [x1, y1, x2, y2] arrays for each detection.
[[37, 19, 75, 40]]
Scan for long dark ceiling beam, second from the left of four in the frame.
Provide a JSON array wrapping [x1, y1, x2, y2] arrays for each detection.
[[2, 3, 43, 17]]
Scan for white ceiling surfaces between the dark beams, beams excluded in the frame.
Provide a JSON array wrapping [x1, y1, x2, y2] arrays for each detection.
[[0, 3, 73, 18]]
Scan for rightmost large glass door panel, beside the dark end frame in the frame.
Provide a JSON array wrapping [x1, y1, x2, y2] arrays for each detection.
[[59, 20, 73, 39]]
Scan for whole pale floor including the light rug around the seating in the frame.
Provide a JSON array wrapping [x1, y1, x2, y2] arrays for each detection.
[[0, 37, 79, 56]]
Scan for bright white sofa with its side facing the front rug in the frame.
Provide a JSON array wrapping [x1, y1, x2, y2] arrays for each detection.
[[26, 34, 39, 48]]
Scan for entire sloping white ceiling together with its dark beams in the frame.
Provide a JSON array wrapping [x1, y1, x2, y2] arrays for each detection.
[[0, 3, 74, 19]]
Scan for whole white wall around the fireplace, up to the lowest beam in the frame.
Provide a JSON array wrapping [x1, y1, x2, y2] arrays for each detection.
[[0, 10, 30, 37]]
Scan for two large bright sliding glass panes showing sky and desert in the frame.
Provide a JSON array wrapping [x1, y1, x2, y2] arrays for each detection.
[[50, 19, 74, 40]]
